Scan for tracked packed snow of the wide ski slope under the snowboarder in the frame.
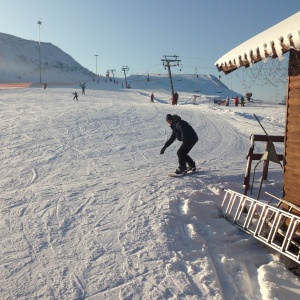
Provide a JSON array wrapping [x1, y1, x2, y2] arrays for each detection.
[[0, 80, 300, 300]]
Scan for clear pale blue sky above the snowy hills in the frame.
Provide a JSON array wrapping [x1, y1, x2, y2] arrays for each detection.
[[0, 0, 300, 100]]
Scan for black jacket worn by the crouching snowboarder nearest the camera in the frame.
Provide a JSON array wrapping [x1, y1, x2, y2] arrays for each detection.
[[164, 117, 198, 148]]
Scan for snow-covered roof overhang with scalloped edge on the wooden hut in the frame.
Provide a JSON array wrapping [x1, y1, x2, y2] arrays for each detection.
[[215, 11, 300, 74]]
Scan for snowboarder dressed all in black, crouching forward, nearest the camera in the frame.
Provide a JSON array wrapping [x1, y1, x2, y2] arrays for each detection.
[[160, 114, 198, 174]]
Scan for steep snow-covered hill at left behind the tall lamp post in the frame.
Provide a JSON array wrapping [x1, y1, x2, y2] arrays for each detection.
[[0, 33, 94, 83]]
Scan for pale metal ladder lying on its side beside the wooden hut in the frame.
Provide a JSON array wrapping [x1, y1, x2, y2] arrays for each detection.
[[221, 190, 300, 263]]
